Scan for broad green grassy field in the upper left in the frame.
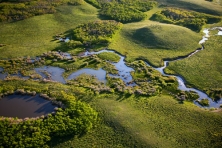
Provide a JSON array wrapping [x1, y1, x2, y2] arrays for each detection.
[[0, 3, 98, 59]]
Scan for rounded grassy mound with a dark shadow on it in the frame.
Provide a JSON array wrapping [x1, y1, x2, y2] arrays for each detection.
[[109, 20, 201, 66]]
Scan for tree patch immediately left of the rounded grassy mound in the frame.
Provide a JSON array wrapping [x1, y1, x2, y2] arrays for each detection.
[[74, 21, 122, 47]]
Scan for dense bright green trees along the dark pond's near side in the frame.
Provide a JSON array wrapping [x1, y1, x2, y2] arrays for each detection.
[[0, 100, 97, 147]]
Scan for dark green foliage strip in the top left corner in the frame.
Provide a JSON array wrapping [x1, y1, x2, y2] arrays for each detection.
[[0, 0, 84, 22]]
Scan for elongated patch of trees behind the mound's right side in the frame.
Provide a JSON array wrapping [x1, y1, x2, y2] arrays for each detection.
[[151, 8, 221, 32]]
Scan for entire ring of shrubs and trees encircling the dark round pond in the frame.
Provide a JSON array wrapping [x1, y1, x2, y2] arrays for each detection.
[[0, 80, 97, 147]]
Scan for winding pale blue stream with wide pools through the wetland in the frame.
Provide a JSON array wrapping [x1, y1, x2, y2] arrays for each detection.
[[0, 27, 222, 108]]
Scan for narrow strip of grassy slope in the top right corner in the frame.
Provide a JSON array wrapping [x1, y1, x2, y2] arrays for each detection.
[[157, 0, 222, 15]]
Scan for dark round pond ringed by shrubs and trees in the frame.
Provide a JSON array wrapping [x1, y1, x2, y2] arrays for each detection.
[[0, 94, 55, 118]]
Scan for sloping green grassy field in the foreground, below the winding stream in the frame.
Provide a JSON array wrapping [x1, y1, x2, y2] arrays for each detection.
[[51, 94, 222, 148]]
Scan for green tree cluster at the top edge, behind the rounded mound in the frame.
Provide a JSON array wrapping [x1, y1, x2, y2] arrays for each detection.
[[86, 0, 157, 23]]
